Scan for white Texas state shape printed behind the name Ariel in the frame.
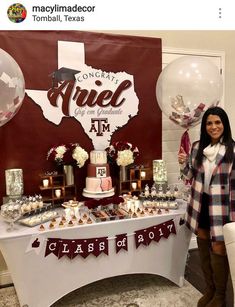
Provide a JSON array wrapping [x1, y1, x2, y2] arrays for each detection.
[[26, 41, 139, 149]]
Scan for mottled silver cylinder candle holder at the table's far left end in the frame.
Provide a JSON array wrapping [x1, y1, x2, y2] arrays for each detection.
[[5, 168, 24, 197]]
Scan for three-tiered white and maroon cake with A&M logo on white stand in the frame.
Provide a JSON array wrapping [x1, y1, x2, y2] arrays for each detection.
[[83, 150, 114, 198]]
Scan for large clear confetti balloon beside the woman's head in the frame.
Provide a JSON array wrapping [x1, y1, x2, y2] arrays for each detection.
[[156, 56, 223, 128]]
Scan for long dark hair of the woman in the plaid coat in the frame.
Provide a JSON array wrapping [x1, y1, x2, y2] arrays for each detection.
[[195, 107, 234, 166]]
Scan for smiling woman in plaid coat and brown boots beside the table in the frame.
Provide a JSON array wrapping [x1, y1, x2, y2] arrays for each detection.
[[178, 107, 235, 307]]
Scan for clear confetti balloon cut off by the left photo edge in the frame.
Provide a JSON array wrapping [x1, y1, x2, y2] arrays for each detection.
[[0, 49, 25, 127]]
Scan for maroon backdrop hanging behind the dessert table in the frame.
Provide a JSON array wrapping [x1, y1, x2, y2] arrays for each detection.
[[0, 31, 162, 199]]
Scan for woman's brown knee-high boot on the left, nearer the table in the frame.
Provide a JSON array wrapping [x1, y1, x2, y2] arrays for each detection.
[[197, 237, 215, 307]]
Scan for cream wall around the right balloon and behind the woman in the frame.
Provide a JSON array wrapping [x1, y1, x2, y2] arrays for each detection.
[[100, 30, 235, 188]]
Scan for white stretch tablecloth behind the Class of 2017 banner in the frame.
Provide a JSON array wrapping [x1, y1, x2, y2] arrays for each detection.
[[0, 205, 191, 307]]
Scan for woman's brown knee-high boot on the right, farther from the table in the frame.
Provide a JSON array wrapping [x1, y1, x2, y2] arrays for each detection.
[[206, 253, 229, 307]]
